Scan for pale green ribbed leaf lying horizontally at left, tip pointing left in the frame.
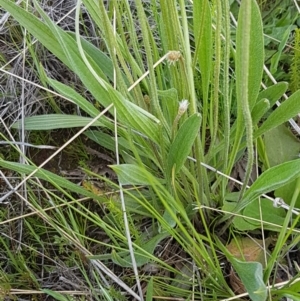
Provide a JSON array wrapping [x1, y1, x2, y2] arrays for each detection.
[[12, 114, 104, 131]]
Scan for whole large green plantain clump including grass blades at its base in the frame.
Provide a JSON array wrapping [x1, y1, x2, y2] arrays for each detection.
[[0, 0, 300, 300]]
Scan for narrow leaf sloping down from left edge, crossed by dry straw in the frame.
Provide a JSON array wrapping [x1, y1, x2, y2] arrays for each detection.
[[0, 160, 103, 198]]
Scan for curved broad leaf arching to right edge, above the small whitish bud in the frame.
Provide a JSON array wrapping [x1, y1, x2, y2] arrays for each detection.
[[233, 159, 300, 213]]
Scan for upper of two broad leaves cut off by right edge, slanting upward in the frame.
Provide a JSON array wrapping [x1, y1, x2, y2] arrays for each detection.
[[254, 90, 300, 139]]
